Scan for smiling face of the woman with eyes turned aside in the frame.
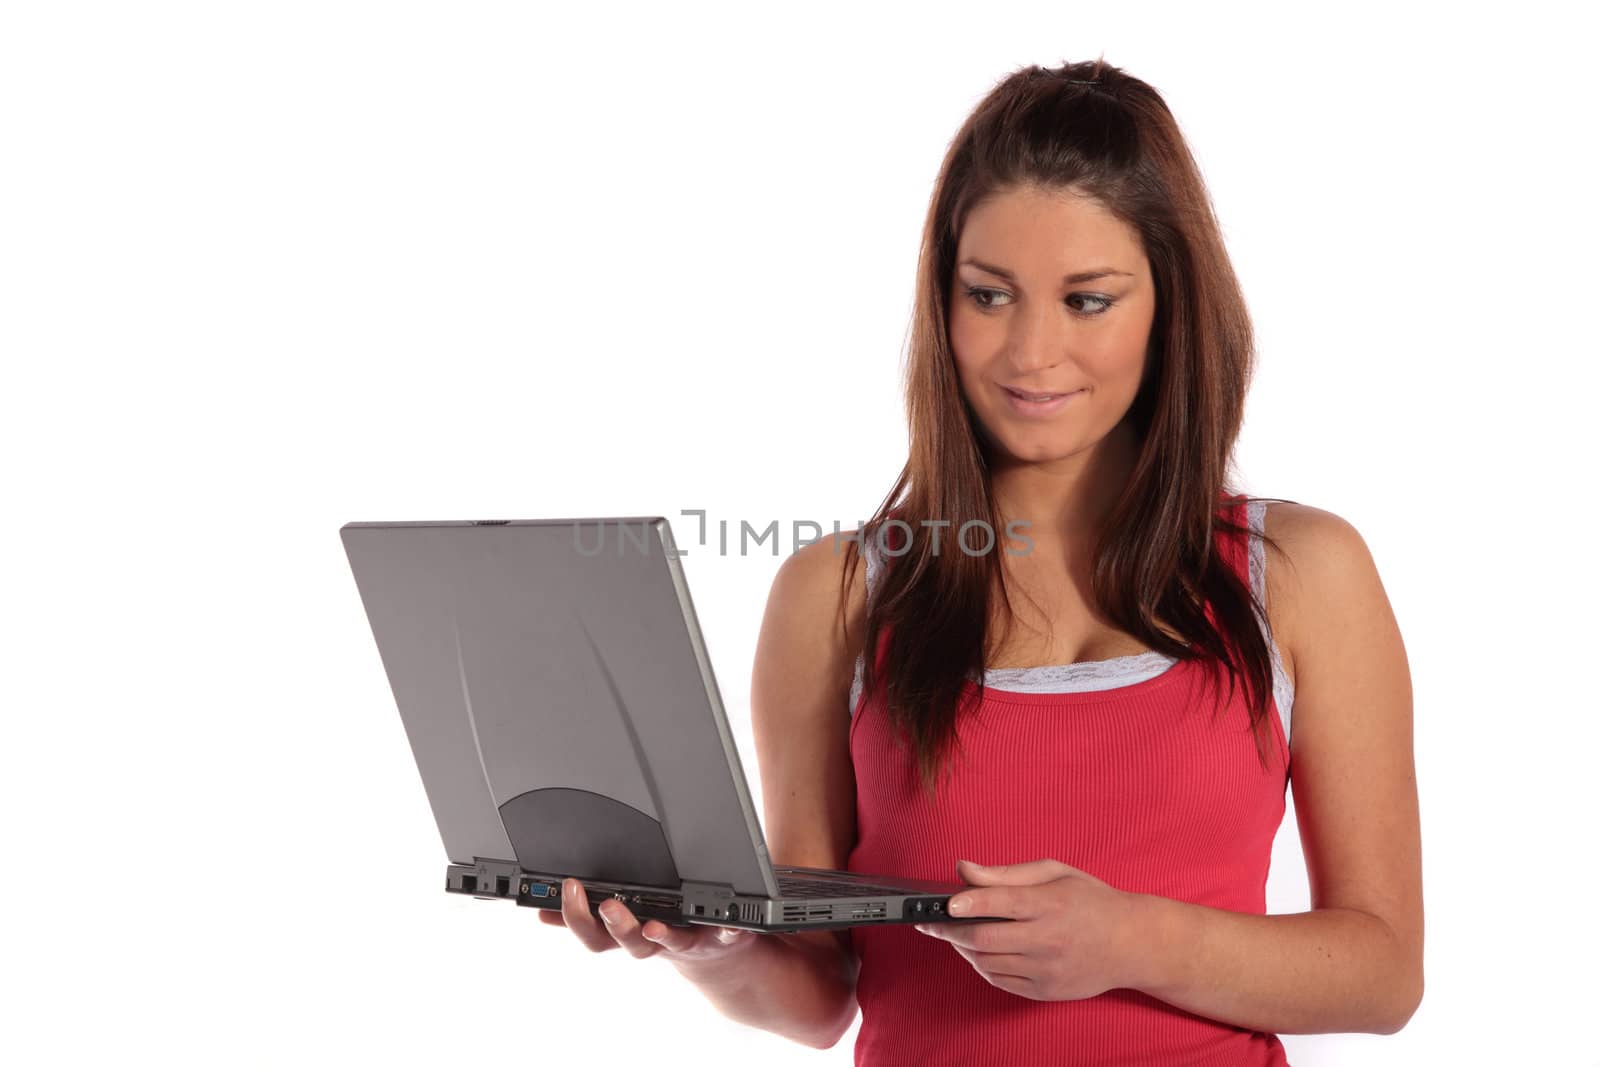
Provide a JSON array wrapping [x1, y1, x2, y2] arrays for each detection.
[[947, 189, 1155, 462]]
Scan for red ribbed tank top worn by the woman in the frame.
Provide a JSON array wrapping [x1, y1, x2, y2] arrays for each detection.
[[845, 496, 1288, 1067]]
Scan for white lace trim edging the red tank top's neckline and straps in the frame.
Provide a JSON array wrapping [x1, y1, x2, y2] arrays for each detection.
[[850, 499, 1294, 739]]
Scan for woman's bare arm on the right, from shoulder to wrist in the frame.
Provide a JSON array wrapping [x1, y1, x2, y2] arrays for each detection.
[[1136, 504, 1422, 1033]]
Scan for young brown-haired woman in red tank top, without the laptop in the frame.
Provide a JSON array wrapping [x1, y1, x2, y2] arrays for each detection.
[[544, 62, 1422, 1067]]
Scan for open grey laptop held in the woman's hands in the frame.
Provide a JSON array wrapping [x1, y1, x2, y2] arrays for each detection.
[[339, 515, 995, 933]]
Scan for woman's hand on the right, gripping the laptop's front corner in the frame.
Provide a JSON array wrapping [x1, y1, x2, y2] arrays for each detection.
[[917, 859, 1141, 1000]]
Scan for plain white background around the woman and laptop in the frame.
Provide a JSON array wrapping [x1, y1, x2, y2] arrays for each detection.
[[0, 2, 1600, 1067]]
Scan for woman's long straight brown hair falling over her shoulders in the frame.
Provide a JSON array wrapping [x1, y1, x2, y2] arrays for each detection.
[[840, 58, 1277, 790]]
